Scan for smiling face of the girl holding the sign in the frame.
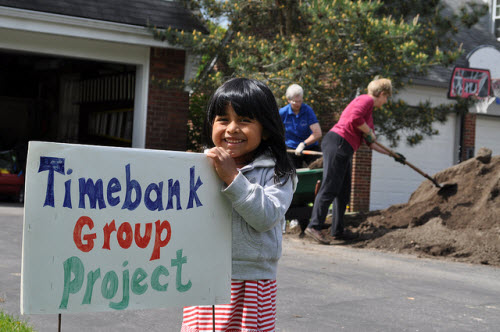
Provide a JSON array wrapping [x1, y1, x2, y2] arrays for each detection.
[[212, 105, 263, 165]]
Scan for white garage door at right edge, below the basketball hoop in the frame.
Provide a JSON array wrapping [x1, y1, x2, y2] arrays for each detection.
[[475, 114, 500, 156]]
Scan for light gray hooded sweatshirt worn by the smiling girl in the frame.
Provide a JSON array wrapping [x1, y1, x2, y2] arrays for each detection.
[[222, 154, 297, 280]]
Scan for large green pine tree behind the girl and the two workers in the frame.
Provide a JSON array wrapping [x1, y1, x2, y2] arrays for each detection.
[[154, 0, 485, 148]]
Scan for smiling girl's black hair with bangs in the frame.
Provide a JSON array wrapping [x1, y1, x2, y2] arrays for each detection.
[[205, 78, 295, 183]]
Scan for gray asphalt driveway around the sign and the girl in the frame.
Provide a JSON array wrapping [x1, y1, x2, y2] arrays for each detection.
[[0, 203, 500, 332]]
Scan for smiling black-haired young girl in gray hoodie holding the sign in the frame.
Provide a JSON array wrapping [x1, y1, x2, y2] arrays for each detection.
[[181, 78, 296, 332]]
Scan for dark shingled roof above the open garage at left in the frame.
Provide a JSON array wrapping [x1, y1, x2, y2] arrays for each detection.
[[0, 0, 206, 31]]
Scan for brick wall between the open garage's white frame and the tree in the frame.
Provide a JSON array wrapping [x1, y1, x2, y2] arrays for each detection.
[[146, 47, 189, 151]]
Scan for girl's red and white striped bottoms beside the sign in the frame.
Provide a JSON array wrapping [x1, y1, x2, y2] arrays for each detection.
[[181, 280, 277, 332]]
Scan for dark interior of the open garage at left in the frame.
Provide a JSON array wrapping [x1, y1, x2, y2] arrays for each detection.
[[0, 51, 136, 168]]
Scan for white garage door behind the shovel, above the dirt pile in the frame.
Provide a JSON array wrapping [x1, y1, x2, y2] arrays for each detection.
[[370, 115, 458, 210]]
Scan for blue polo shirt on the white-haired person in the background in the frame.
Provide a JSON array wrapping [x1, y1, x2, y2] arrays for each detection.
[[280, 103, 318, 149]]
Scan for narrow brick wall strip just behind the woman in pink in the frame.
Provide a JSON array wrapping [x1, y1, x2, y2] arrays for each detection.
[[349, 144, 372, 212]]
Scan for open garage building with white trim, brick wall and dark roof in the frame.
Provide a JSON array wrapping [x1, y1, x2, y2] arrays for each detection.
[[0, 0, 205, 200]]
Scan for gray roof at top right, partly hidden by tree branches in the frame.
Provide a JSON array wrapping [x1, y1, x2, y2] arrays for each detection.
[[413, 0, 500, 87]]
